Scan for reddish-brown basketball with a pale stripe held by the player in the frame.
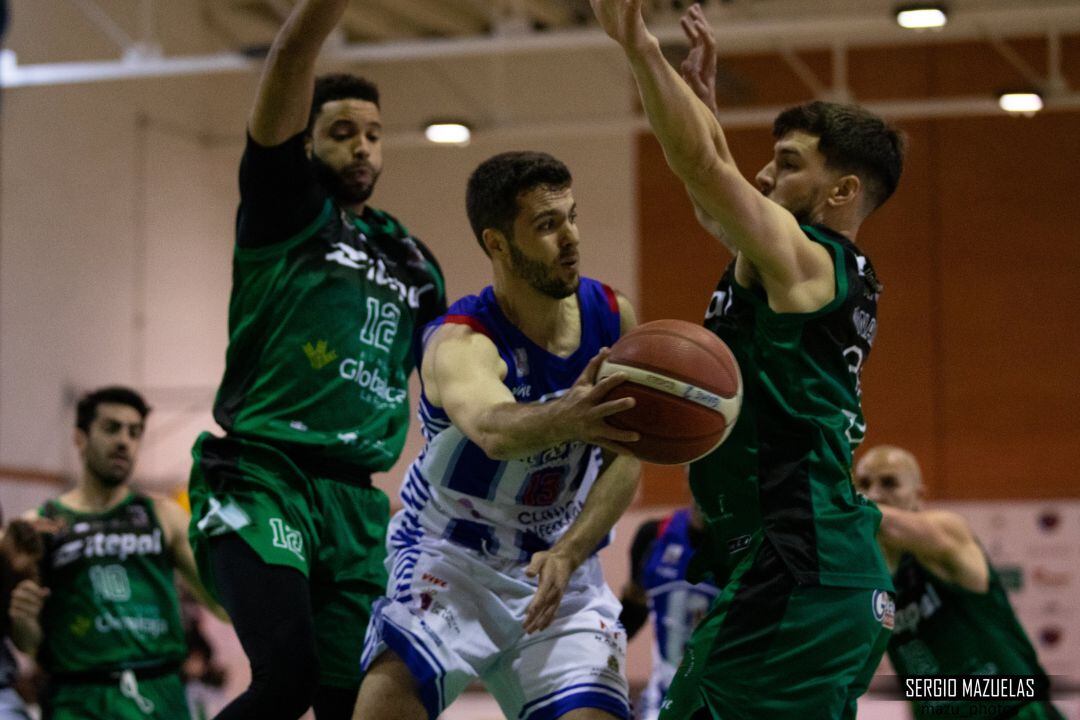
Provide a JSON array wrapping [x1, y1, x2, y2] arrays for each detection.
[[597, 320, 742, 465]]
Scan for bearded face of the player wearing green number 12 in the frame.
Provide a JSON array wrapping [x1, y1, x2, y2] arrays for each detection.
[[311, 98, 382, 206]]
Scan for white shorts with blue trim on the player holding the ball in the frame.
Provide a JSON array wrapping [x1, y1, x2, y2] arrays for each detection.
[[362, 520, 630, 720]]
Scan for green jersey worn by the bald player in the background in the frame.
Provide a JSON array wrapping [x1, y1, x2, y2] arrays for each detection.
[[888, 554, 1049, 718]]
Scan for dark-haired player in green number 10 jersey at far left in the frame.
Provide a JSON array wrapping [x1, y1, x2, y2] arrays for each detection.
[[10, 386, 225, 720]]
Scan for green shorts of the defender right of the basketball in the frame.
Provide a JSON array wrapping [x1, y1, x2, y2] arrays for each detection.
[[660, 540, 892, 720]]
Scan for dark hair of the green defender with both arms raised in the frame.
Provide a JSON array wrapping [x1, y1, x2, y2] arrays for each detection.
[[772, 100, 904, 210]]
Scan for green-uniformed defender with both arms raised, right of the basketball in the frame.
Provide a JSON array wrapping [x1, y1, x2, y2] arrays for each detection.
[[592, 0, 903, 720]]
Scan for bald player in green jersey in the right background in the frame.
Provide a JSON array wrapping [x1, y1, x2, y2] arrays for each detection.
[[855, 445, 1063, 720]]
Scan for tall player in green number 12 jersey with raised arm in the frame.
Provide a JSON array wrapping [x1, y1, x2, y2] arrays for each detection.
[[183, 0, 446, 720]]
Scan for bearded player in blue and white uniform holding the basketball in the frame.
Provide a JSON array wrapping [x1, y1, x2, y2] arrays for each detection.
[[353, 152, 639, 720]]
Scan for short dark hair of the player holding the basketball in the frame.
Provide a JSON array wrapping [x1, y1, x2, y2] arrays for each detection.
[[465, 151, 573, 255]]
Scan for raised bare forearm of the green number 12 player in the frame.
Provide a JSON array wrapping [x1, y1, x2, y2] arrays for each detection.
[[247, 0, 349, 147]]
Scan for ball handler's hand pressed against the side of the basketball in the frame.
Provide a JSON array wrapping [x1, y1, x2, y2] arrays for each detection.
[[558, 348, 640, 453]]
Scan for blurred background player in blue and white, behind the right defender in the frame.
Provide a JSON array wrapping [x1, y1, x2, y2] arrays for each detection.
[[619, 505, 719, 720]]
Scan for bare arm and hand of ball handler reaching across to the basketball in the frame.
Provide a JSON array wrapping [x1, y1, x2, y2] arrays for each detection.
[[420, 324, 637, 460]]
